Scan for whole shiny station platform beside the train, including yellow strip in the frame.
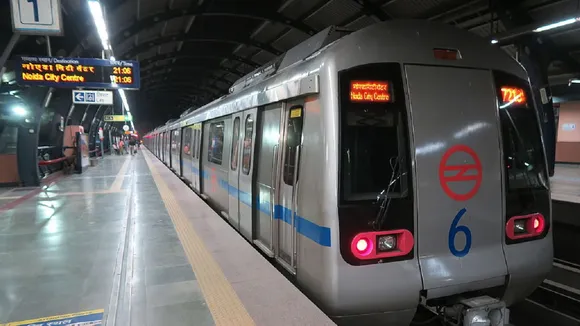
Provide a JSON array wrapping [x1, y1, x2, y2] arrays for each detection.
[[0, 147, 334, 326]]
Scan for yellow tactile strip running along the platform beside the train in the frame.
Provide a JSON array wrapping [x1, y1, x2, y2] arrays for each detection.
[[143, 151, 255, 326]]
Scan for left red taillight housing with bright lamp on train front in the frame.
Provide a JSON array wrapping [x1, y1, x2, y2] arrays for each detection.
[[350, 230, 415, 260]]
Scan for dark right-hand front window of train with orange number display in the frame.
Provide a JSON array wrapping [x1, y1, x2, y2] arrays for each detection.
[[493, 71, 550, 244]]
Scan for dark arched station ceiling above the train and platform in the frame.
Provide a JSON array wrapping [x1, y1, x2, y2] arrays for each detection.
[[0, 0, 580, 130]]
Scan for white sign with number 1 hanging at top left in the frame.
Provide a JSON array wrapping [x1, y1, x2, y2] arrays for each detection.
[[10, 0, 63, 35]]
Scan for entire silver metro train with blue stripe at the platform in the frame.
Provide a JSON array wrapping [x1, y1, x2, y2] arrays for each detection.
[[145, 21, 553, 325]]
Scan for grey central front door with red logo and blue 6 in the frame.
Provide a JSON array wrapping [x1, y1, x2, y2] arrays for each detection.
[[405, 65, 507, 298]]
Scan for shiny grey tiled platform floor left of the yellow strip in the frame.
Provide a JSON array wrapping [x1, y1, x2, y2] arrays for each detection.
[[0, 155, 214, 326]]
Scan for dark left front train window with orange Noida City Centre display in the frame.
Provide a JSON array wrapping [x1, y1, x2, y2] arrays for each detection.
[[339, 63, 411, 202]]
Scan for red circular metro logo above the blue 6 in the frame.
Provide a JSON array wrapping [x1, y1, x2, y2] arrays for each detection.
[[439, 145, 483, 201]]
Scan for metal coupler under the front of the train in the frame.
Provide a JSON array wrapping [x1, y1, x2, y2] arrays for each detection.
[[444, 296, 509, 326]]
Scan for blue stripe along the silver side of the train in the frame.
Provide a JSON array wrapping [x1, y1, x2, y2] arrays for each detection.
[[183, 162, 330, 247]]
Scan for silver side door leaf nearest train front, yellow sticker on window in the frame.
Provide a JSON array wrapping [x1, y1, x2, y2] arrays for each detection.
[[276, 100, 304, 273]]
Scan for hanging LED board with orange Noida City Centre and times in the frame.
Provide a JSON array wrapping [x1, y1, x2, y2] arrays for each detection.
[[15, 56, 140, 89]]
